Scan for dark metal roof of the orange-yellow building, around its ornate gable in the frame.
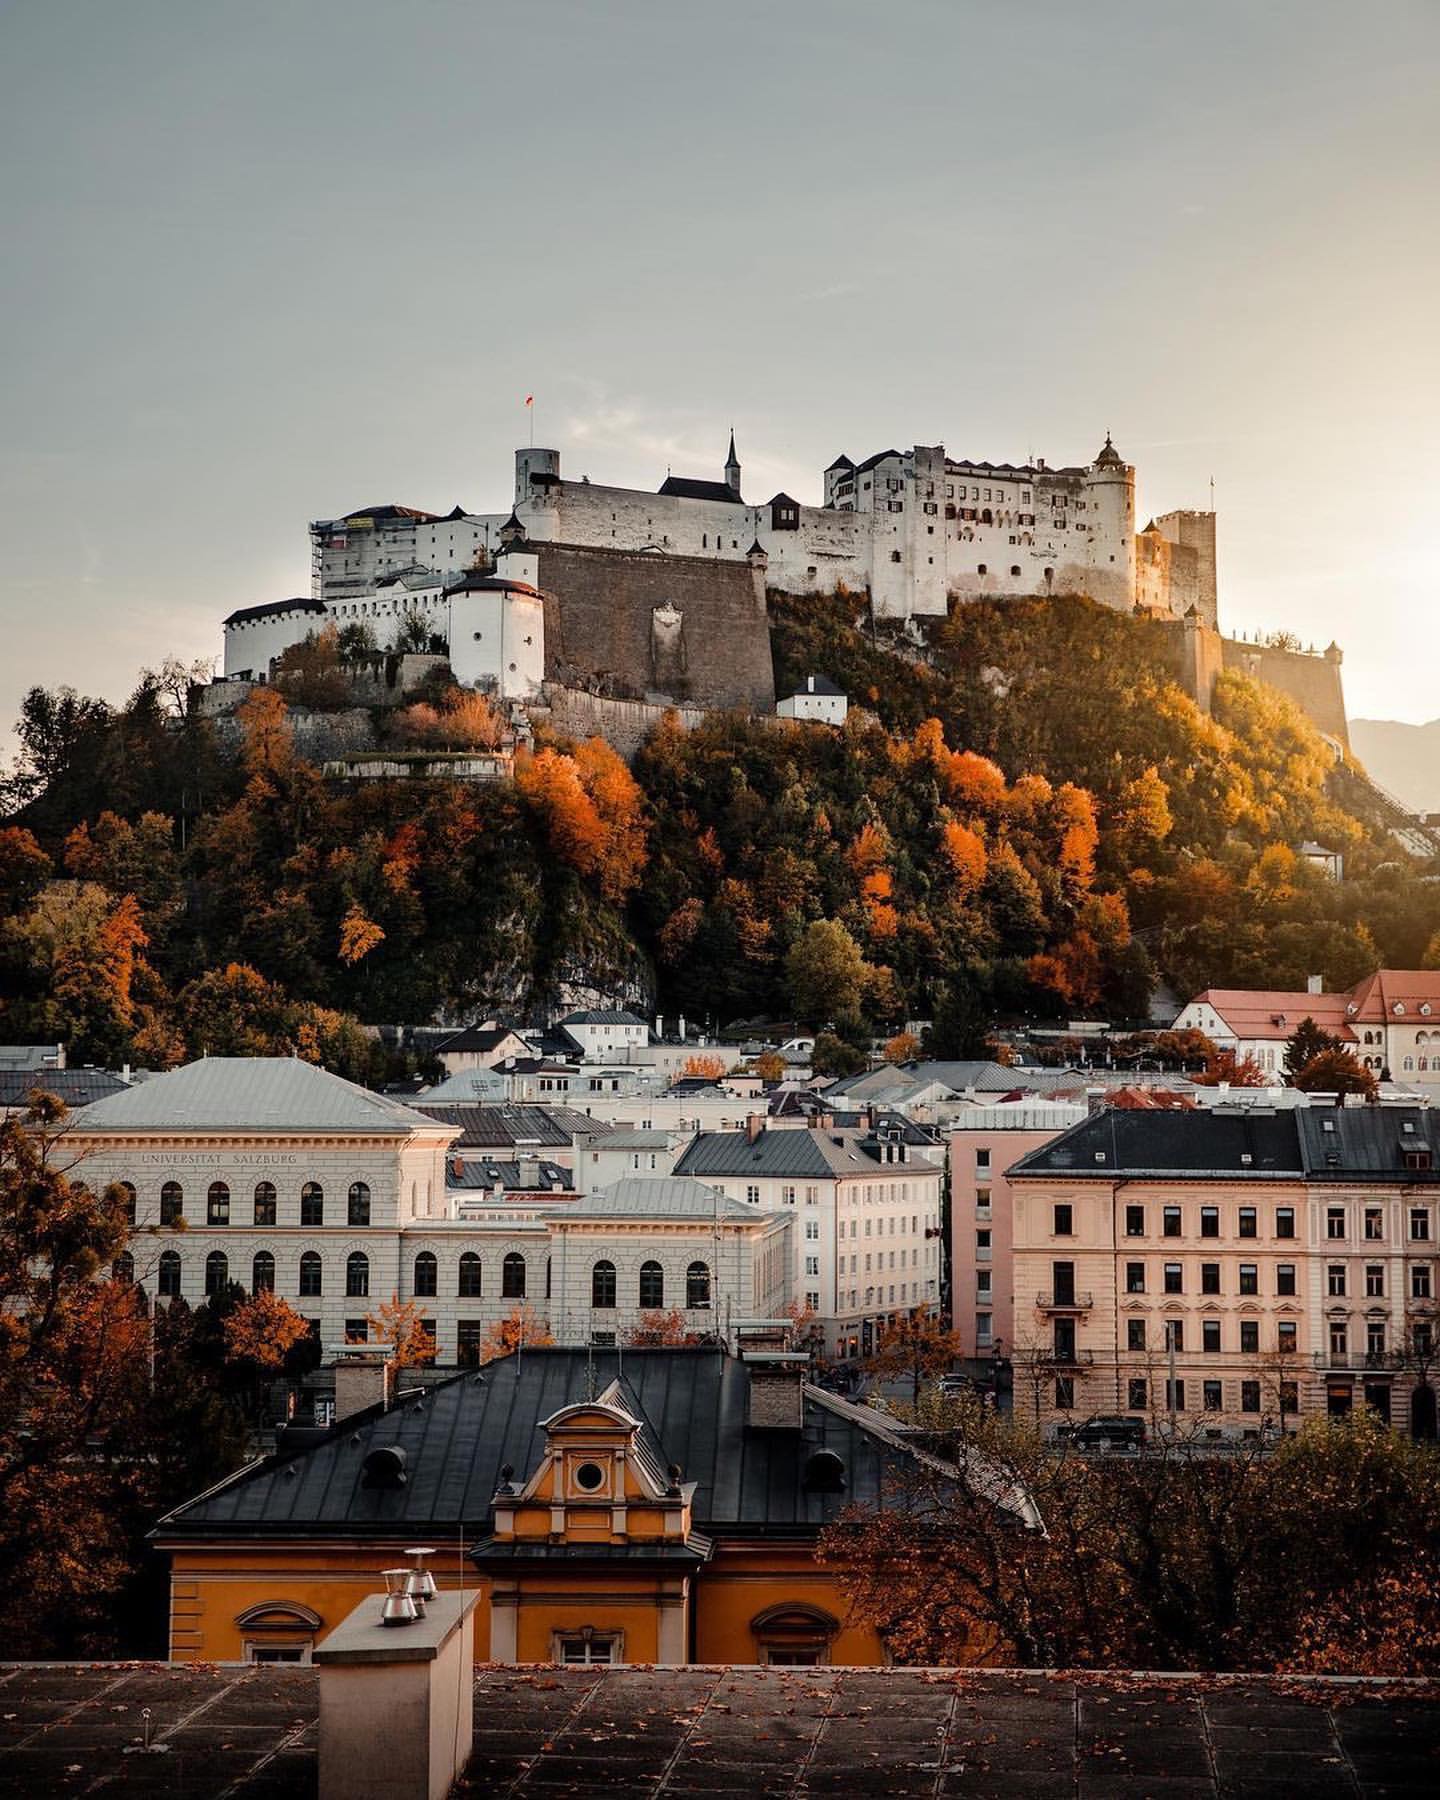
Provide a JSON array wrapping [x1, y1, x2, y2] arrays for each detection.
[[157, 1348, 904, 1543]]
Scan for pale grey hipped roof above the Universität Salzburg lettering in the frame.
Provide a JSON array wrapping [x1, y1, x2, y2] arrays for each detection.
[[74, 1057, 455, 1136]]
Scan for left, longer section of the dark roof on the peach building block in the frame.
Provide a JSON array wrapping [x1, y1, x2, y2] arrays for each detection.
[[1010, 1107, 1305, 1181]]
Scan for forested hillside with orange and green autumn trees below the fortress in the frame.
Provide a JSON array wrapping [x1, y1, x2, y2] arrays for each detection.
[[0, 596, 1440, 1075]]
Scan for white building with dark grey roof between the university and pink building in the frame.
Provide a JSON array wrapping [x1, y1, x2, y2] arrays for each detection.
[[675, 1118, 943, 1357]]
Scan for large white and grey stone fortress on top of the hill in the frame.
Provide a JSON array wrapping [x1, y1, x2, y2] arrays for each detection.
[[216, 434, 1345, 742]]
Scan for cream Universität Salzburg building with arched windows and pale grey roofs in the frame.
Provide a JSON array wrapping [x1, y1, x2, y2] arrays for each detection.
[[67, 1057, 792, 1363]]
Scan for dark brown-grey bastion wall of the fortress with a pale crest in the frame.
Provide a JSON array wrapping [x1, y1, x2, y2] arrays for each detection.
[[529, 544, 776, 711]]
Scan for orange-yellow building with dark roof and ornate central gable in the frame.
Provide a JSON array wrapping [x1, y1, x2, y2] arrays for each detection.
[[155, 1346, 909, 1663]]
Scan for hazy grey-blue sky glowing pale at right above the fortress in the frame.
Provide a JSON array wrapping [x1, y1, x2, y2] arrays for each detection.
[[0, 0, 1440, 745]]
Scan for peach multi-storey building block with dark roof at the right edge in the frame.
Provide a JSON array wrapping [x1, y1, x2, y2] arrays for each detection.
[[1010, 1103, 1440, 1436]]
